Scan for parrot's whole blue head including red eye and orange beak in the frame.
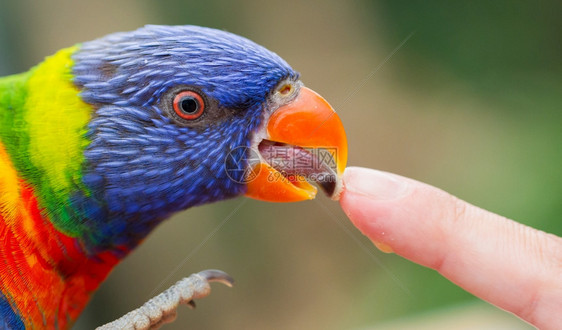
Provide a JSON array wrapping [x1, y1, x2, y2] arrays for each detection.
[[68, 26, 347, 249]]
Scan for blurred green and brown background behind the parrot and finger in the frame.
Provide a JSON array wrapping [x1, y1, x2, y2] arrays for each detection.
[[0, 0, 562, 329]]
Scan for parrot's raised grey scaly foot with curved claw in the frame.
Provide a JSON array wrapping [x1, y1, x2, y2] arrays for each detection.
[[97, 269, 234, 330]]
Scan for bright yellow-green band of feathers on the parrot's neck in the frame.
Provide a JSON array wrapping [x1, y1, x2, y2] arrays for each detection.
[[0, 47, 92, 237]]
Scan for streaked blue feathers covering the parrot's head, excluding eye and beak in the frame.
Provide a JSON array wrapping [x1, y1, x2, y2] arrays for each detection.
[[73, 26, 298, 250]]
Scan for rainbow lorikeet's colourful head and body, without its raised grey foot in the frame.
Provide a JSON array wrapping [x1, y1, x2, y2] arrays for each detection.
[[0, 26, 347, 329]]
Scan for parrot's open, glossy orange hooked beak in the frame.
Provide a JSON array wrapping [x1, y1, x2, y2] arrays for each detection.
[[246, 87, 347, 202]]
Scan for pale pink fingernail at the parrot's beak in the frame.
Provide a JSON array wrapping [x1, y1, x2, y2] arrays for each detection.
[[343, 167, 408, 200]]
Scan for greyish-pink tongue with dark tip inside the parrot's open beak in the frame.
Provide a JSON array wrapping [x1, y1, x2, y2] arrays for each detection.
[[258, 140, 338, 197]]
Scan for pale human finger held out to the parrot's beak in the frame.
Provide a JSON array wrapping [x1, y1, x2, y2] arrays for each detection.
[[340, 167, 562, 329]]
